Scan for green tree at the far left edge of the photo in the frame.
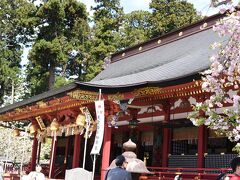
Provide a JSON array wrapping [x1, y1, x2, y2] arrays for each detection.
[[0, 0, 35, 105]]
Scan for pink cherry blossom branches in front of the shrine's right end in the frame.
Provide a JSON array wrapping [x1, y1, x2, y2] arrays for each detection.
[[189, 2, 240, 147]]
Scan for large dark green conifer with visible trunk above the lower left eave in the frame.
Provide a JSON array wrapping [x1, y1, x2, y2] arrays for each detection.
[[27, 0, 89, 95]]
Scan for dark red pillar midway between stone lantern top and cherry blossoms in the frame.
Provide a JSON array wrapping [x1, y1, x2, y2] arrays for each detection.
[[162, 103, 171, 167]]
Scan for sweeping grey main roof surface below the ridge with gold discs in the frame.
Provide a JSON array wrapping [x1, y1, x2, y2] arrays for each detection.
[[90, 28, 219, 86]]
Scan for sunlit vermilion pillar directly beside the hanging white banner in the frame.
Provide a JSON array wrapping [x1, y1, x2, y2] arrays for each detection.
[[101, 123, 112, 180]]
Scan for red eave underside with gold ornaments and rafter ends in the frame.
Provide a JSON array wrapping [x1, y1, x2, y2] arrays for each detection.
[[0, 81, 204, 121]]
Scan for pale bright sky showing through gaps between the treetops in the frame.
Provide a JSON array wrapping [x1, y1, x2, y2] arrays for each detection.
[[22, 0, 239, 65]]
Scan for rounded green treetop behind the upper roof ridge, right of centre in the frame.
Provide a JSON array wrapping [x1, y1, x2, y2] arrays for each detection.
[[150, 0, 200, 37]]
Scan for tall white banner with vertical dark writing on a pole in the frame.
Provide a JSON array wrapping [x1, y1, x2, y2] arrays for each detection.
[[91, 100, 104, 154]]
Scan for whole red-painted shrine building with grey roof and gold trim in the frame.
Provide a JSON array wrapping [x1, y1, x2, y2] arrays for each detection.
[[0, 11, 236, 180]]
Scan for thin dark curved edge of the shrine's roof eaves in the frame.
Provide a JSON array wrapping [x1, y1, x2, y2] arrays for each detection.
[[0, 74, 200, 114]]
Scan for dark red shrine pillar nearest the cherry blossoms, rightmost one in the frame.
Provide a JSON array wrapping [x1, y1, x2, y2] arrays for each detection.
[[197, 125, 208, 168]]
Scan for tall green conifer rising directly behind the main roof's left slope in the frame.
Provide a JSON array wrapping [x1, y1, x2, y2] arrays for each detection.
[[86, 0, 123, 80]]
